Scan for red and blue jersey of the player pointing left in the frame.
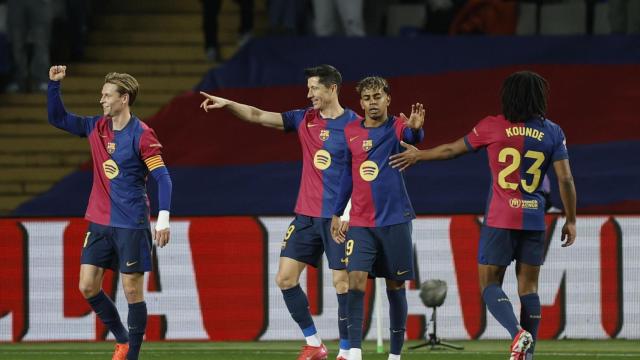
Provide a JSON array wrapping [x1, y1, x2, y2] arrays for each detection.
[[282, 108, 358, 218]]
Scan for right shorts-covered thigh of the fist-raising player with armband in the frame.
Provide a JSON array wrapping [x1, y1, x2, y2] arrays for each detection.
[[114, 228, 153, 273]]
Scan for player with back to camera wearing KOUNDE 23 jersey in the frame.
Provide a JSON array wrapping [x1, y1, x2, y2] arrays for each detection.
[[390, 71, 576, 360]]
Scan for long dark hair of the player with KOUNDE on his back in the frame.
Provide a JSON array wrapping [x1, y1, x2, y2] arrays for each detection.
[[500, 71, 549, 123]]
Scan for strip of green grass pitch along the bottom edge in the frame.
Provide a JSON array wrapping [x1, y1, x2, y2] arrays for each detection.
[[0, 340, 640, 360]]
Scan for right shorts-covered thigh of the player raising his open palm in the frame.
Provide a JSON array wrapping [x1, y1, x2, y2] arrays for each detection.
[[374, 222, 415, 282]]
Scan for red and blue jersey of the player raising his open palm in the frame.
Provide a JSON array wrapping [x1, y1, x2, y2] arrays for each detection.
[[334, 116, 424, 227]]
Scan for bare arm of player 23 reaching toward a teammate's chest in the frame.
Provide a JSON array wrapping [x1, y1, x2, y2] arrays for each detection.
[[389, 138, 468, 171]]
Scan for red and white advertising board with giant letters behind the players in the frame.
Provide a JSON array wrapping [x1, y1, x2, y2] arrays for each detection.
[[0, 215, 640, 342]]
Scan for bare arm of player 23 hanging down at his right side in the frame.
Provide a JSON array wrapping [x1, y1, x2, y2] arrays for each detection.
[[553, 159, 577, 247]]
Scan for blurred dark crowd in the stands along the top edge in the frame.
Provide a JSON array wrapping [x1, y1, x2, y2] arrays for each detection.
[[0, 0, 640, 93]]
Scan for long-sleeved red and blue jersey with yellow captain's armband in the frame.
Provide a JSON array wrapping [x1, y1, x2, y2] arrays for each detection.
[[47, 81, 164, 229]]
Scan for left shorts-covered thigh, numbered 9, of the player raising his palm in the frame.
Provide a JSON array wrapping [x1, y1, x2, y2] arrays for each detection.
[[345, 226, 378, 273]]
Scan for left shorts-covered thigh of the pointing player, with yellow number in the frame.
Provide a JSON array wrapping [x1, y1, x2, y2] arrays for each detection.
[[280, 215, 324, 267]]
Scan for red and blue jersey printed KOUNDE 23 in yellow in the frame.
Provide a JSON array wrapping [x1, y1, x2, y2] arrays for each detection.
[[464, 115, 569, 230]]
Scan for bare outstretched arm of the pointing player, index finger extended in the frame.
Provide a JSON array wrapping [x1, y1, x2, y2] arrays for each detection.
[[200, 91, 284, 130]]
